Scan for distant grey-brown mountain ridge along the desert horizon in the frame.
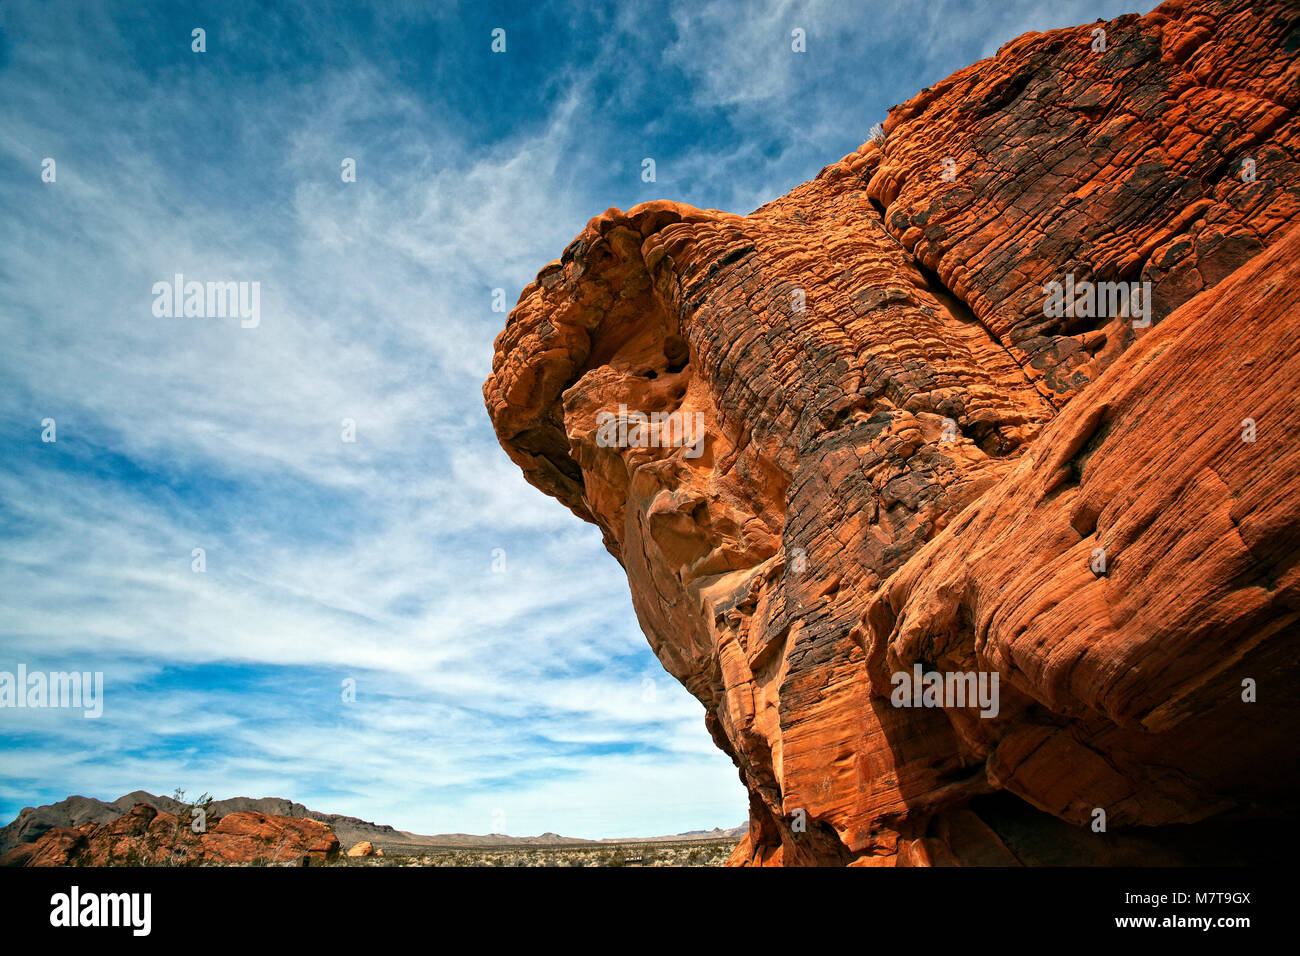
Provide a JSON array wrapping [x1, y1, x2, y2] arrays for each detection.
[[0, 790, 748, 855]]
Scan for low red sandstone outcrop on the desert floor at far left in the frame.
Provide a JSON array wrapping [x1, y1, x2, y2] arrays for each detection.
[[0, 804, 339, 866]]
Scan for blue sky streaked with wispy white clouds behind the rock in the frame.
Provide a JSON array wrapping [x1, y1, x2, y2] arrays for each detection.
[[0, 0, 1148, 838]]
